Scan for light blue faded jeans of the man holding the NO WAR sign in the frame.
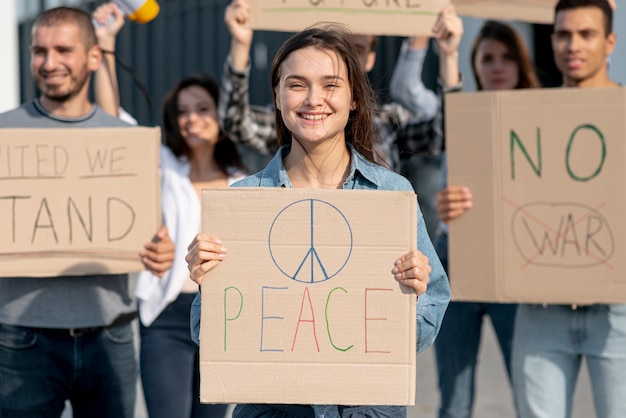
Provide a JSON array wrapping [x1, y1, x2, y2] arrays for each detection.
[[512, 305, 626, 418]]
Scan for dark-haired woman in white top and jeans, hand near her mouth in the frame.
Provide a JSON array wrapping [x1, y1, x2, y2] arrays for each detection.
[[135, 75, 244, 418]]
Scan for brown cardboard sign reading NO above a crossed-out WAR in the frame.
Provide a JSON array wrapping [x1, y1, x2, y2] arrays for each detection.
[[446, 88, 626, 304]]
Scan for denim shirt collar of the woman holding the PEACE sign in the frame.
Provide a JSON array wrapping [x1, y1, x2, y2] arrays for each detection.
[[260, 144, 381, 189]]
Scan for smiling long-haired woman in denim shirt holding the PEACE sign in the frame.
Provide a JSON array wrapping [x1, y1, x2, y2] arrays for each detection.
[[187, 22, 450, 418]]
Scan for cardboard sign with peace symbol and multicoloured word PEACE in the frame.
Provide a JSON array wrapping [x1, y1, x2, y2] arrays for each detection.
[[200, 188, 417, 405]]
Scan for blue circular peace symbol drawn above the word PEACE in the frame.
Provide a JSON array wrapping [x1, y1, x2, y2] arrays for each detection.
[[268, 199, 353, 283]]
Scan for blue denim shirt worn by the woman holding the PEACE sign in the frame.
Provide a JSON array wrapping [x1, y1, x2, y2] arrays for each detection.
[[191, 145, 450, 418]]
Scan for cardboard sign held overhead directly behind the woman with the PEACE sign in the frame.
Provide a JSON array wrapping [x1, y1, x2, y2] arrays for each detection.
[[246, 0, 449, 36]]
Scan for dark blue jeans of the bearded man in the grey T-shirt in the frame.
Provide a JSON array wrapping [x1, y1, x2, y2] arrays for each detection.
[[0, 324, 137, 418]]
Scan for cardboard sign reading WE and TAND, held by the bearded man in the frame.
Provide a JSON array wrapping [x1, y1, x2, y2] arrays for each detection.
[[0, 128, 161, 277]]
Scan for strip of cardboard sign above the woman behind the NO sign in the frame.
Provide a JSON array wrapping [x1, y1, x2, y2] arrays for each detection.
[[452, 0, 556, 24]]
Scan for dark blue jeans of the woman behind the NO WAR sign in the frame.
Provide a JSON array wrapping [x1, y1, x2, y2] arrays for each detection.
[[435, 234, 517, 418]]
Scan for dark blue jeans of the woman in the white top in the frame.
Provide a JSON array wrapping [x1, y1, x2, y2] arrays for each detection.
[[140, 293, 228, 418]]
